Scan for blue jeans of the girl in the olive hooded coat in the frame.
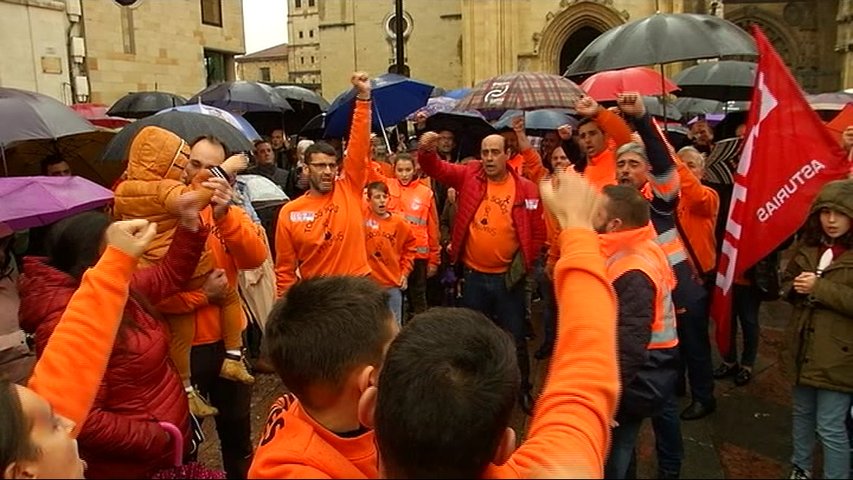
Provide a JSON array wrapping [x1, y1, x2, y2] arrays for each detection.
[[791, 385, 851, 478]]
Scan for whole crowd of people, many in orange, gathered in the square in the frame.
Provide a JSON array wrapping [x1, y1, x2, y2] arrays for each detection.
[[0, 68, 853, 478]]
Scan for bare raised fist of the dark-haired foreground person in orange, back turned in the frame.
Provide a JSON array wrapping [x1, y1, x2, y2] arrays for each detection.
[[539, 169, 599, 229]]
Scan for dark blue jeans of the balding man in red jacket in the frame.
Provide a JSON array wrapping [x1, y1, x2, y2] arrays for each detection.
[[462, 268, 530, 390]]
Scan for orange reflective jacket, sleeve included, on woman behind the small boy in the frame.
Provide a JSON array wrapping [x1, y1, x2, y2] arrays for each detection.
[[386, 178, 441, 265]]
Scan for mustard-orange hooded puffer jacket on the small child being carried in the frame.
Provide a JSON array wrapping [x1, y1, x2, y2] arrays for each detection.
[[113, 126, 213, 271]]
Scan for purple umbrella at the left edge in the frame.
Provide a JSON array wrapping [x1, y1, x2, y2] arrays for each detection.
[[0, 177, 113, 230]]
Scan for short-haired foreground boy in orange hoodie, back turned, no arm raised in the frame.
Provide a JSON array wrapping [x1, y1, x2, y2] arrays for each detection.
[[249, 276, 399, 478]]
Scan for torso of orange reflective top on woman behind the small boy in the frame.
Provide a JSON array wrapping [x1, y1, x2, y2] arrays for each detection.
[[388, 180, 435, 258]]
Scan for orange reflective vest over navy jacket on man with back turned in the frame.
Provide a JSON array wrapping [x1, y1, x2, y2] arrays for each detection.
[[606, 240, 678, 350]]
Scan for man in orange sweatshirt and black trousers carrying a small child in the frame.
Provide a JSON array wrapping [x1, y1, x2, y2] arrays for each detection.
[[157, 137, 269, 478]]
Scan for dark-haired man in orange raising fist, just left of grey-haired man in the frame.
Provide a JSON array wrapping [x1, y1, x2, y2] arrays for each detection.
[[575, 96, 631, 189]]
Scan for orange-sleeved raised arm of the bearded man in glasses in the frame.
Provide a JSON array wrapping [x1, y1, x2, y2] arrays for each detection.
[[342, 72, 371, 196]]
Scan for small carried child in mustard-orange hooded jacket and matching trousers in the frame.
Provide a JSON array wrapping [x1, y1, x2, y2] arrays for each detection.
[[113, 126, 254, 417]]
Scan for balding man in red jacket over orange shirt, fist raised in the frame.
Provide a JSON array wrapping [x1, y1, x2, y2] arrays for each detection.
[[418, 132, 545, 414]]
